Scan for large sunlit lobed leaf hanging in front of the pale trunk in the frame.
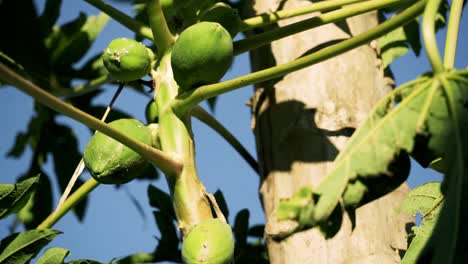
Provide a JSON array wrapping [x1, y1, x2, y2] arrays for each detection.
[[282, 70, 468, 235]]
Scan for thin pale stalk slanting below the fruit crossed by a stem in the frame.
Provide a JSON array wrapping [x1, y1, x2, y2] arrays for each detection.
[[37, 178, 99, 229]]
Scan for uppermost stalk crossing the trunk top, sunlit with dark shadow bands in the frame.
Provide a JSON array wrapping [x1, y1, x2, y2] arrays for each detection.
[[240, 0, 362, 31]]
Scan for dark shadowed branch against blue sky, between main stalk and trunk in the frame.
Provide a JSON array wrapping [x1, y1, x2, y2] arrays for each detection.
[[192, 106, 259, 174]]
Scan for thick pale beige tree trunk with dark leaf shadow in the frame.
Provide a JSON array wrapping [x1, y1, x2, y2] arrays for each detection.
[[245, 0, 414, 264]]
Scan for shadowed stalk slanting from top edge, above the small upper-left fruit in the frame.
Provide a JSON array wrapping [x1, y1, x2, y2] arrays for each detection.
[[84, 0, 154, 40]]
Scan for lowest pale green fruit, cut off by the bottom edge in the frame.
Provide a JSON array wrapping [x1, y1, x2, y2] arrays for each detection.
[[182, 218, 234, 264]]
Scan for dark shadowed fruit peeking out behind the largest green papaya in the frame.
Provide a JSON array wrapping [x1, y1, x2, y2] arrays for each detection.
[[200, 2, 241, 38]]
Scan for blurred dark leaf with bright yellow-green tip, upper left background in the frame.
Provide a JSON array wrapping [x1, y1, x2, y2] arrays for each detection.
[[46, 13, 109, 70]]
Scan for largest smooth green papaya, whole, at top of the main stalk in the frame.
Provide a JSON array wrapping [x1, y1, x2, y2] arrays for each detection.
[[171, 22, 233, 90]]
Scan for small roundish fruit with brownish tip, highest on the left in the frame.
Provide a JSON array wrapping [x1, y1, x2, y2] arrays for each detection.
[[102, 38, 151, 81]]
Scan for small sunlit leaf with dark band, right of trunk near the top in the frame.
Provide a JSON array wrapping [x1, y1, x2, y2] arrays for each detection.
[[378, 27, 408, 69]]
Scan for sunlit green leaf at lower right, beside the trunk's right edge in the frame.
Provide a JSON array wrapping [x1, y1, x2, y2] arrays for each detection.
[[401, 182, 444, 264]]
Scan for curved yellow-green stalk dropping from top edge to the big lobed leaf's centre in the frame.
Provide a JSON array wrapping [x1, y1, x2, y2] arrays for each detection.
[[422, 0, 444, 74]]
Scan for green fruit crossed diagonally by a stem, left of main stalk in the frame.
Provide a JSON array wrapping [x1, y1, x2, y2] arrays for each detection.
[[83, 119, 152, 184]]
